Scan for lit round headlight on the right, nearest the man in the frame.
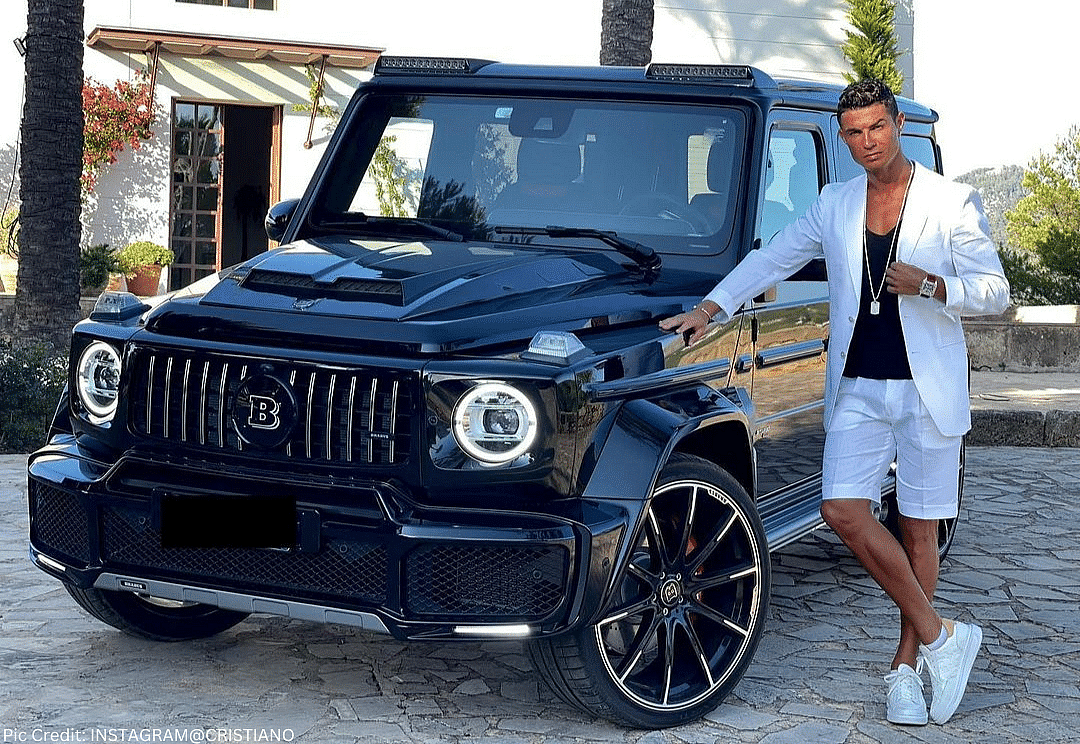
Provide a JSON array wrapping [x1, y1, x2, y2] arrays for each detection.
[[454, 382, 537, 464]]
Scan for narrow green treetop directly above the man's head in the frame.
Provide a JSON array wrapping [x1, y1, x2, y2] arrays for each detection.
[[841, 0, 904, 94]]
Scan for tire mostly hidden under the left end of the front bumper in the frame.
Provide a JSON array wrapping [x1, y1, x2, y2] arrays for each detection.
[[64, 582, 247, 641]]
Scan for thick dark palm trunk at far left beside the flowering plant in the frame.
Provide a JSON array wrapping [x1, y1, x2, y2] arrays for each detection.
[[12, 0, 83, 351]]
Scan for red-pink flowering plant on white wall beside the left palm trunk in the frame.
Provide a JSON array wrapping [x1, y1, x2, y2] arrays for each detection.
[[82, 70, 157, 193]]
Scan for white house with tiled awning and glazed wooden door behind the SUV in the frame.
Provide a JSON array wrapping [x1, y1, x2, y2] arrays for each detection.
[[0, 0, 914, 289]]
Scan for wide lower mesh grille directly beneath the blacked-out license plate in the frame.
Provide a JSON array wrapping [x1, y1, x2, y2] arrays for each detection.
[[102, 506, 388, 605]]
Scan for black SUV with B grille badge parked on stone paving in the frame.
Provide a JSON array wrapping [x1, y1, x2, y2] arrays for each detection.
[[28, 56, 954, 727]]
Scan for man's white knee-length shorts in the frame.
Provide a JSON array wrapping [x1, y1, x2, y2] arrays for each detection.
[[822, 377, 963, 519]]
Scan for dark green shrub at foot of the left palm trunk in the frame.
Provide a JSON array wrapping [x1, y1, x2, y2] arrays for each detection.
[[0, 341, 67, 455]]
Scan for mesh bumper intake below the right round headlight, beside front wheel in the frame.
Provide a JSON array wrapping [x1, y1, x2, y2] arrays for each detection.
[[405, 545, 569, 620]]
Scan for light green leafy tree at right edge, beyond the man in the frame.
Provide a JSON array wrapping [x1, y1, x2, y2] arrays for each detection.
[[1001, 125, 1080, 305]]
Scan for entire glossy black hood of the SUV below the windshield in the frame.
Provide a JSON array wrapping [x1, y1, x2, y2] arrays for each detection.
[[147, 238, 682, 351]]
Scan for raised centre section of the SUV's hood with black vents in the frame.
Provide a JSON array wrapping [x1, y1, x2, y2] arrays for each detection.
[[209, 240, 627, 321]]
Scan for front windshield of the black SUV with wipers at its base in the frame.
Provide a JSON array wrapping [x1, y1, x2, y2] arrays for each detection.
[[311, 94, 746, 255]]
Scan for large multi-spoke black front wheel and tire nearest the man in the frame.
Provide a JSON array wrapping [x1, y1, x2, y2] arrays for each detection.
[[529, 455, 771, 729]]
